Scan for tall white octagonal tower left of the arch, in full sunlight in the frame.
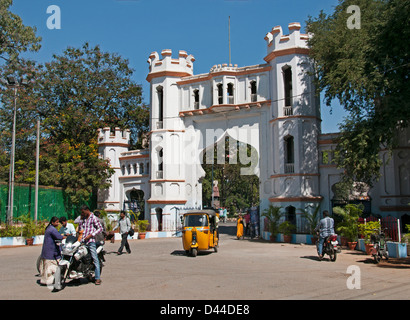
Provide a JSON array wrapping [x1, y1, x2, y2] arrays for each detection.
[[147, 49, 195, 231]]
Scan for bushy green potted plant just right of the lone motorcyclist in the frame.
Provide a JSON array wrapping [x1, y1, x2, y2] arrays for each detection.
[[333, 204, 363, 250]]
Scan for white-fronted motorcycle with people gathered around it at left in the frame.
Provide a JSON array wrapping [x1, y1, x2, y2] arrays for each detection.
[[54, 236, 105, 291]]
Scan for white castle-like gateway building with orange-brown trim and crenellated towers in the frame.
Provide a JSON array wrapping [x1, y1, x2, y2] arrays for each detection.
[[98, 23, 410, 236]]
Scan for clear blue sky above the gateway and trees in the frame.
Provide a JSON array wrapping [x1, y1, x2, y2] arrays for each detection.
[[12, 0, 344, 133]]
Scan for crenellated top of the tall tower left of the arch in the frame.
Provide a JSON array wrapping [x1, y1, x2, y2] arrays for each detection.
[[147, 49, 195, 82]]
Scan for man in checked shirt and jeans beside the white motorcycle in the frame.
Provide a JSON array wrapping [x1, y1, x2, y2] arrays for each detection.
[[79, 205, 103, 285]]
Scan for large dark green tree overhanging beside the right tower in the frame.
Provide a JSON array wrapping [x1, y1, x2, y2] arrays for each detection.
[[307, 0, 410, 185]]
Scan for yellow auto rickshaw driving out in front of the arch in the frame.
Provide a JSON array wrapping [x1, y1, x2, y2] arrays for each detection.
[[182, 210, 219, 257]]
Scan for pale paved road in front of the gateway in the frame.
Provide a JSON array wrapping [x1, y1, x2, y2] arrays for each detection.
[[0, 223, 410, 300]]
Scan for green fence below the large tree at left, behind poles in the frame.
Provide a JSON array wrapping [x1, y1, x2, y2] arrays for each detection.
[[0, 182, 97, 222]]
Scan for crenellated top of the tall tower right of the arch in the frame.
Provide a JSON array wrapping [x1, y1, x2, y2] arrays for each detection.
[[264, 22, 309, 62]]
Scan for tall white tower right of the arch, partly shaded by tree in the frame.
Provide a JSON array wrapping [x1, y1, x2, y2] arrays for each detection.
[[264, 23, 321, 223]]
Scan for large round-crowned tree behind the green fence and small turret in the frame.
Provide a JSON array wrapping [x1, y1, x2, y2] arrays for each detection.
[[0, 43, 149, 205]]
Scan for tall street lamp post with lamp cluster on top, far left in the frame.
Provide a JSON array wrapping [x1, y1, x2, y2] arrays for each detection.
[[1, 76, 28, 224]]
